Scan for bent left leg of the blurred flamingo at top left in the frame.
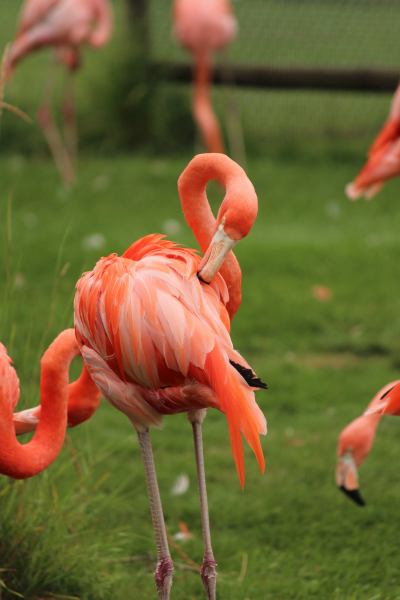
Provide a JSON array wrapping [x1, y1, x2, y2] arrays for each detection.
[[38, 62, 75, 185]]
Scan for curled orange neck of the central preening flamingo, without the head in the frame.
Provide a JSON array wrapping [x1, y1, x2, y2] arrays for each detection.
[[178, 154, 245, 319]]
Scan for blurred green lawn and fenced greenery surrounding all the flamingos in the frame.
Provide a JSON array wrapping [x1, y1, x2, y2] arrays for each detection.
[[0, 0, 400, 600]]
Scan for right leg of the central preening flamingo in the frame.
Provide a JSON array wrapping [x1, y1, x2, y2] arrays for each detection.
[[188, 409, 217, 600]]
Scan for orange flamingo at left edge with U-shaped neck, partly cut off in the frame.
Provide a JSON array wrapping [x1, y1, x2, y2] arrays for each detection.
[[0, 329, 100, 479]]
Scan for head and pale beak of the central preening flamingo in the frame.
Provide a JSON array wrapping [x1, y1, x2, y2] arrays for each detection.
[[197, 171, 258, 283]]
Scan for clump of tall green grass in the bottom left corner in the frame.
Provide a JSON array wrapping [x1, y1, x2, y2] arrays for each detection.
[[0, 447, 130, 600]]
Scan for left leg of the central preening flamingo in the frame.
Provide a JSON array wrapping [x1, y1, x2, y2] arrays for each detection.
[[137, 429, 174, 600]]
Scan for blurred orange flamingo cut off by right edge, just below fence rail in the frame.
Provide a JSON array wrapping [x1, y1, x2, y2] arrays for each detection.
[[346, 86, 400, 200]]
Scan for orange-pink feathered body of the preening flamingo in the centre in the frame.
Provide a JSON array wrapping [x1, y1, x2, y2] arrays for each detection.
[[75, 235, 266, 484]]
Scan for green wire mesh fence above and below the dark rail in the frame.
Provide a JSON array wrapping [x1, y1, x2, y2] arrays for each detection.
[[0, 0, 400, 151]]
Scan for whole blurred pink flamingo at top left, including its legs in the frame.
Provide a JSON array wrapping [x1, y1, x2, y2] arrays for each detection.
[[6, 0, 113, 184]]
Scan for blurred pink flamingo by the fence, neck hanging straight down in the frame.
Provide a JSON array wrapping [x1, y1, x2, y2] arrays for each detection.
[[173, 0, 237, 154]]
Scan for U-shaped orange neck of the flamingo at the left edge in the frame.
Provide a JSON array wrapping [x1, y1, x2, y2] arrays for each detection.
[[0, 329, 79, 479]]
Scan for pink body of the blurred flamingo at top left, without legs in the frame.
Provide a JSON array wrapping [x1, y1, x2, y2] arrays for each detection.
[[8, 0, 113, 75]]
